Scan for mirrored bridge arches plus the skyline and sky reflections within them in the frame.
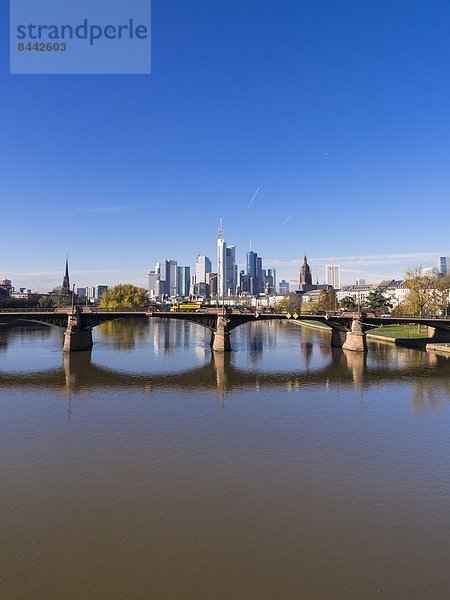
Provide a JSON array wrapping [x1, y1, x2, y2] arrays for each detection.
[[0, 320, 450, 409]]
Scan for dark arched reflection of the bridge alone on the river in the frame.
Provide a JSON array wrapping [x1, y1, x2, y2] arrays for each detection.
[[0, 342, 450, 406]]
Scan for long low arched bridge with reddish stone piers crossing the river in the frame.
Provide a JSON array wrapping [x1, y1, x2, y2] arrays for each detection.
[[0, 306, 450, 352]]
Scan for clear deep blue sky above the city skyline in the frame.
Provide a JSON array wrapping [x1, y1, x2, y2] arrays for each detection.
[[0, 0, 450, 291]]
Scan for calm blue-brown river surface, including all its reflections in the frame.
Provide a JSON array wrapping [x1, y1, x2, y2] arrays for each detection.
[[0, 321, 450, 600]]
